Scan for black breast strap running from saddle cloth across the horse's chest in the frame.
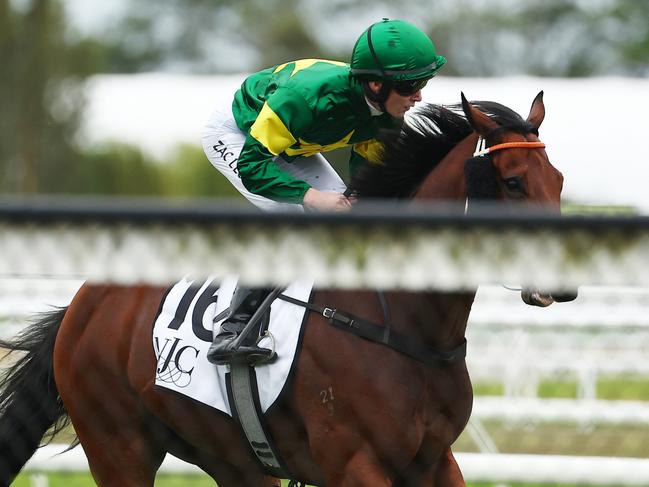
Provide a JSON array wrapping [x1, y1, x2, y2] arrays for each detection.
[[278, 294, 466, 366]]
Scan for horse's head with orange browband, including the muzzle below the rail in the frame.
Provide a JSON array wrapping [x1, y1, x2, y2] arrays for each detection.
[[462, 91, 577, 307]]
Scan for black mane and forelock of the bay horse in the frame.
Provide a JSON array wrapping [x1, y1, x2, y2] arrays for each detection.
[[348, 101, 535, 199]]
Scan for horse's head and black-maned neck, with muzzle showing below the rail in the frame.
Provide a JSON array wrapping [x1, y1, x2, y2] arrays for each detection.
[[350, 92, 576, 306]]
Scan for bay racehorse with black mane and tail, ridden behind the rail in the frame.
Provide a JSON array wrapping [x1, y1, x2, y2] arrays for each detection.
[[0, 92, 563, 487]]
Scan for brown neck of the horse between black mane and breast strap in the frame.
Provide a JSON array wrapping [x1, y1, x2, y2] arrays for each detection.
[[388, 133, 478, 349]]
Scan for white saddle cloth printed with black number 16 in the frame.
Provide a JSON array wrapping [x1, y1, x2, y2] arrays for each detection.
[[153, 277, 313, 416]]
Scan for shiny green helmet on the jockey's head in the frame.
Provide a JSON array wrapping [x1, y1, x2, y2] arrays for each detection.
[[351, 19, 446, 81]]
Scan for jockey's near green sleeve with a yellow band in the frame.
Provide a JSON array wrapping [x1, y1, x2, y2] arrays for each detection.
[[237, 88, 313, 203]]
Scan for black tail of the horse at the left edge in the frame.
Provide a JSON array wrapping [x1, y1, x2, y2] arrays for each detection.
[[0, 308, 69, 486]]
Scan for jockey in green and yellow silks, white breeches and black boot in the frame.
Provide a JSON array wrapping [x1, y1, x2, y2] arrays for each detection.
[[203, 19, 446, 363]]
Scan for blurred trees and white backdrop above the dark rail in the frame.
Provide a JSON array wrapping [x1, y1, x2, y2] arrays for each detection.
[[0, 0, 649, 210]]
